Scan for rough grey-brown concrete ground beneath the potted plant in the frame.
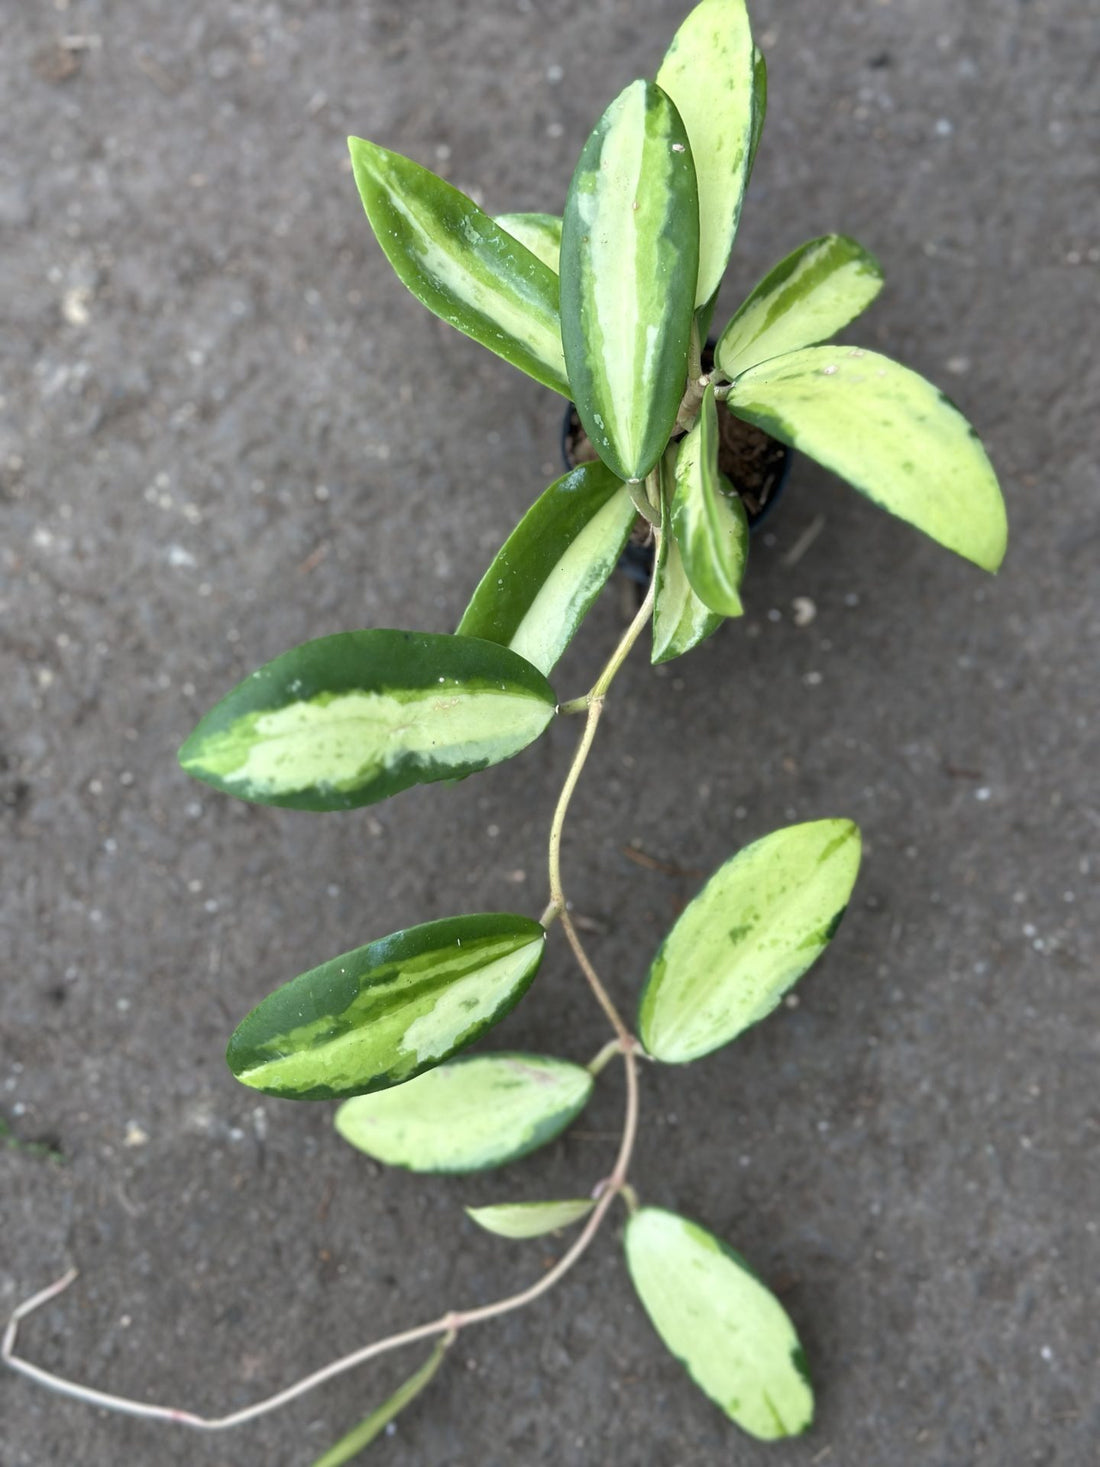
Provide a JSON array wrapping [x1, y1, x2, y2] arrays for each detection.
[[0, 0, 1100, 1467]]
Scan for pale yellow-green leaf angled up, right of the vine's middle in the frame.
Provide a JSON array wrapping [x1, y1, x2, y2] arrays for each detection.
[[638, 820, 859, 1065]]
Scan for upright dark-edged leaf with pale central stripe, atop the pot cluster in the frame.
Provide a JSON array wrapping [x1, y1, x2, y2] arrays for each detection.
[[562, 81, 698, 480]]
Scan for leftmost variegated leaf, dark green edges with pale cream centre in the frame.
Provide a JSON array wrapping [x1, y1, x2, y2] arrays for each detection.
[[179, 631, 556, 810]]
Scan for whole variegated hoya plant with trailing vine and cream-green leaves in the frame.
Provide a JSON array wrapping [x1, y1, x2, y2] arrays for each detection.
[[4, 0, 1006, 1467]]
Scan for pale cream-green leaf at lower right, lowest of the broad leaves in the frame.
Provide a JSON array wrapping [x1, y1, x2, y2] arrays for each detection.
[[623, 1207, 814, 1442]]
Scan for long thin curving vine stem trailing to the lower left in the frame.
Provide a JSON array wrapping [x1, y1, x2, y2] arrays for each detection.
[[0, 536, 656, 1432]]
